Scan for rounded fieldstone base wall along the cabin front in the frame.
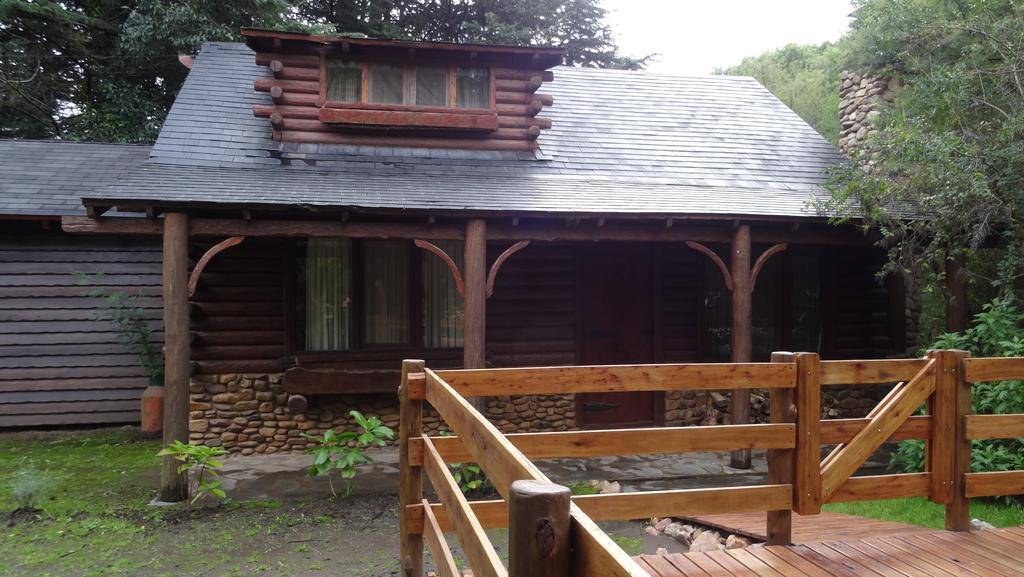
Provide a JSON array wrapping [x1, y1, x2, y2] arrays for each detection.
[[188, 374, 885, 455]]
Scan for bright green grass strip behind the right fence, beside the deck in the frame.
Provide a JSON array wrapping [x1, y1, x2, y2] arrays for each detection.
[[822, 497, 1024, 529]]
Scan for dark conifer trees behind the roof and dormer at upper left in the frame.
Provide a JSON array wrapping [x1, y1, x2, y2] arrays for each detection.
[[0, 0, 647, 142]]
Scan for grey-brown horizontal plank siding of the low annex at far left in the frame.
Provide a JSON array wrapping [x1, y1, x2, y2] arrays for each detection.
[[0, 233, 163, 427]]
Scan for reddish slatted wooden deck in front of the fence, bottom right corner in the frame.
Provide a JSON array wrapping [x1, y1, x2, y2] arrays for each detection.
[[634, 527, 1024, 577]]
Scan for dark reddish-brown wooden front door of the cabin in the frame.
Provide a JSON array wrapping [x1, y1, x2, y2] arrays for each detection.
[[577, 243, 665, 428]]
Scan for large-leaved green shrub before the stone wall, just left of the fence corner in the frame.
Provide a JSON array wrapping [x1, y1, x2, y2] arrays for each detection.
[[302, 411, 394, 497]]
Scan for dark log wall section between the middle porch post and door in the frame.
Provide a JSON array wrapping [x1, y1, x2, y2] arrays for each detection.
[[486, 243, 580, 367]]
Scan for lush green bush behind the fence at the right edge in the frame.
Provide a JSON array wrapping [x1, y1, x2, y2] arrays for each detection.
[[890, 297, 1024, 485]]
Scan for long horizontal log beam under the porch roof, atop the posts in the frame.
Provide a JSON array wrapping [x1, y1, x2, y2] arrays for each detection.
[[61, 216, 872, 246]]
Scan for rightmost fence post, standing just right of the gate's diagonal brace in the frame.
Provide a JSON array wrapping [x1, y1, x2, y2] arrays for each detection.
[[932, 351, 973, 531]]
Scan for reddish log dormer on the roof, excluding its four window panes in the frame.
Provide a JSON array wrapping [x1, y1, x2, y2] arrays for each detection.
[[243, 30, 563, 151]]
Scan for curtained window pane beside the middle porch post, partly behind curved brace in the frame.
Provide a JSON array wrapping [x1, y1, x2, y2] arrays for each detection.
[[421, 241, 463, 348]]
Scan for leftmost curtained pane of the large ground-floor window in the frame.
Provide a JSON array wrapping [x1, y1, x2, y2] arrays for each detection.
[[305, 239, 352, 351]]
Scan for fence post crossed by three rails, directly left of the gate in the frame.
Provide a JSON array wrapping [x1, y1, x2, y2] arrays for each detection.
[[767, 353, 799, 545]]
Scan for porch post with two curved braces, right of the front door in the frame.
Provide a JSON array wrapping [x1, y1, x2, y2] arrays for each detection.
[[729, 224, 754, 468]]
